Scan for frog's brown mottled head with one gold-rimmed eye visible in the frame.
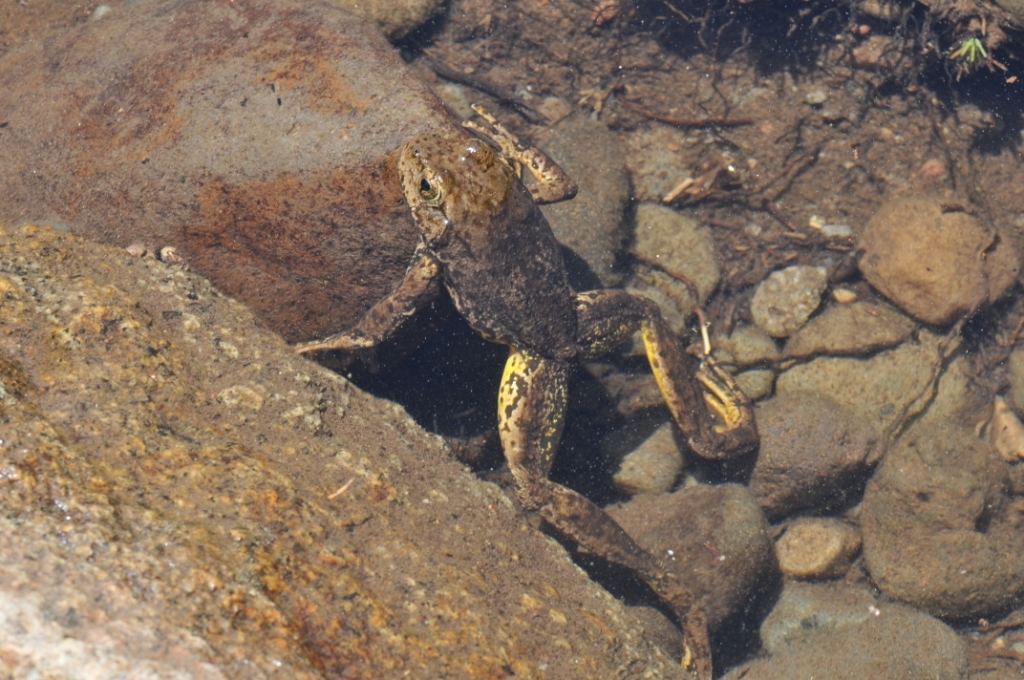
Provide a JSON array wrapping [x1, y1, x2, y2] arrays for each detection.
[[398, 132, 517, 250]]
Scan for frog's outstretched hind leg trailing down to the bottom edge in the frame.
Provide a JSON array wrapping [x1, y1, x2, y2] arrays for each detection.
[[498, 349, 711, 680]]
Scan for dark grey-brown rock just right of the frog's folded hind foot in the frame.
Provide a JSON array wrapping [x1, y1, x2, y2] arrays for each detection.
[[750, 392, 881, 520]]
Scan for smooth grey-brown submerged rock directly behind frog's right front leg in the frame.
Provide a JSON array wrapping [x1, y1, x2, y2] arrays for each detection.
[[542, 116, 631, 289]]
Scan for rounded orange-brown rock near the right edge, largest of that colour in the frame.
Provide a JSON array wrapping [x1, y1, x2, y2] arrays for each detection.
[[857, 197, 1020, 325]]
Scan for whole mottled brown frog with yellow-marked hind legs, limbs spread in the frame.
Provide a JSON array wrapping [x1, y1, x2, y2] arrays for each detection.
[[298, 116, 757, 679]]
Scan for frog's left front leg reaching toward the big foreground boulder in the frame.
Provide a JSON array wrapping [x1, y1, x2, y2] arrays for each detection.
[[295, 252, 441, 354]]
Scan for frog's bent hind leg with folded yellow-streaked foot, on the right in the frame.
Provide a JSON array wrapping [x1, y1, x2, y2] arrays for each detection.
[[575, 290, 758, 458]]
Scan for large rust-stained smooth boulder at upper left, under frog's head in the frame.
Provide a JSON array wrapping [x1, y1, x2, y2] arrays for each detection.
[[0, 0, 459, 342]]
